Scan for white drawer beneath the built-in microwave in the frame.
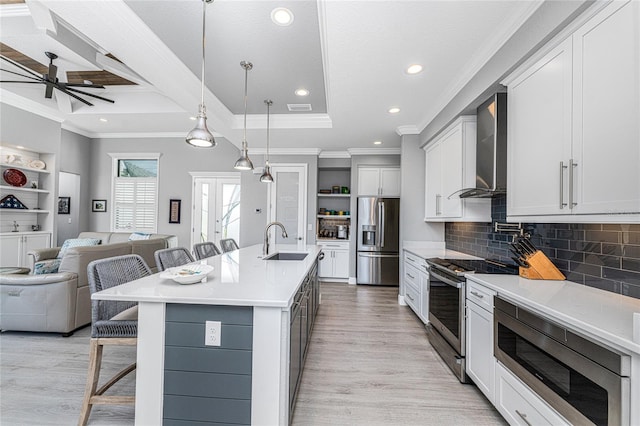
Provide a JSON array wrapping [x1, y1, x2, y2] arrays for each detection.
[[494, 361, 570, 426]]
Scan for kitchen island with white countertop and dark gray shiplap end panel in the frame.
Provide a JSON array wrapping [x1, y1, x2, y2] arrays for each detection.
[[92, 245, 320, 425]]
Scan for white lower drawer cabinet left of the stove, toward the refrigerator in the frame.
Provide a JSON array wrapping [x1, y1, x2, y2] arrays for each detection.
[[402, 251, 429, 324]]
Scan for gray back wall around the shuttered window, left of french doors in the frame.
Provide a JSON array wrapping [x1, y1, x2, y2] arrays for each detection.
[[89, 138, 240, 247]]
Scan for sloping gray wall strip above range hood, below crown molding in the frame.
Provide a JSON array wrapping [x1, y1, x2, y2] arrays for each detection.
[[420, 0, 592, 144]]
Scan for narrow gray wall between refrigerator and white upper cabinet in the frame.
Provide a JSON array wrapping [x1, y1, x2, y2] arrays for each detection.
[[400, 135, 444, 244]]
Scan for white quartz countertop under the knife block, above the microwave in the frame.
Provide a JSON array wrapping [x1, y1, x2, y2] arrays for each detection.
[[466, 274, 640, 354]]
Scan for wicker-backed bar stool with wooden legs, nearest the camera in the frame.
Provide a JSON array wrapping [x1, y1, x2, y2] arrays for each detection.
[[78, 254, 151, 426]]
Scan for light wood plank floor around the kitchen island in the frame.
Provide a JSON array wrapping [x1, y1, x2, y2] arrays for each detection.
[[0, 283, 506, 426]]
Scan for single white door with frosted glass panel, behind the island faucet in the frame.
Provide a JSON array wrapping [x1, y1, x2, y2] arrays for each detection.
[[269, 164, 307, 244]]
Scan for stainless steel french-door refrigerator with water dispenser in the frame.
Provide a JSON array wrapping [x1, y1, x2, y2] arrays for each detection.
[[356, 197, 400, 286]]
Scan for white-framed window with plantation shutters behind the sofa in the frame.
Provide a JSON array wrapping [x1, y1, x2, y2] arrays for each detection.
[[112, 155, 158, 233]]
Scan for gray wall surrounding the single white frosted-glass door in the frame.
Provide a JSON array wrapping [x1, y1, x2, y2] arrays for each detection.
[[240, 152, 318, 247]]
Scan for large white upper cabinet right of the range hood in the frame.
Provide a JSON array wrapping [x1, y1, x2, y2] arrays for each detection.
[[504, 2, 640, 222]]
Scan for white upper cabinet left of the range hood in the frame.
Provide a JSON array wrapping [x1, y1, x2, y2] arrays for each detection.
[[424, 116, 491, 222]]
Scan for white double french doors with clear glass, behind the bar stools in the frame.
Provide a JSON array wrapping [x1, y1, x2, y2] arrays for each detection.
[[191, 174, 240, 247]]
